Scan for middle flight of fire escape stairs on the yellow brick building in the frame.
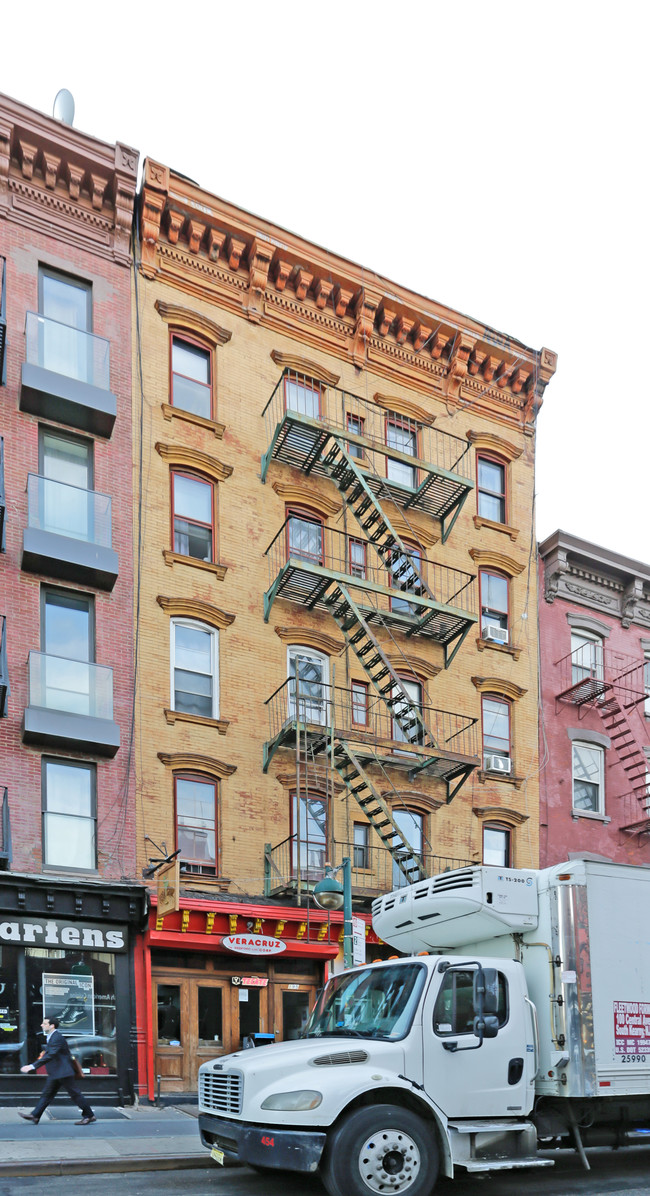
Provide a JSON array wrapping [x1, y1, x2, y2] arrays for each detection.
[[324, 584, 438, 750]]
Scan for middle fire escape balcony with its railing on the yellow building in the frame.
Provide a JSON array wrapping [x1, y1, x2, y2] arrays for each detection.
[[265, 517, 478, 666]]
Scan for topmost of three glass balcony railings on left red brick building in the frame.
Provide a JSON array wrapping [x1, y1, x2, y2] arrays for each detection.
[[25, 311, 110, 390]]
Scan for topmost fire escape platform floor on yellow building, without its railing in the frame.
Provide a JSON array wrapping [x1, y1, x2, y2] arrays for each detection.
[[262, 411, 474, 520]]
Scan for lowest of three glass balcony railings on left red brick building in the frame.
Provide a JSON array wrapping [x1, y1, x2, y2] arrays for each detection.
[[29, 652, 113, 720]]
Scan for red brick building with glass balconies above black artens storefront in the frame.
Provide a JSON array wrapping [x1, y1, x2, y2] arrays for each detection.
[[0, 97, 144, 1102]]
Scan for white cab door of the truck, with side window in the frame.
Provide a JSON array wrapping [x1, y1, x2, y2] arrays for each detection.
[[423, 960, 530, 1117]]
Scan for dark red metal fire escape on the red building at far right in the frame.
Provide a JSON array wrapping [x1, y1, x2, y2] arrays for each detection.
[[555, 643, 650, 834]]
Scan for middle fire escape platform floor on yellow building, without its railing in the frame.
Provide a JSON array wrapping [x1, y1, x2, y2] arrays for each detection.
[[265, 557, 478, 646]]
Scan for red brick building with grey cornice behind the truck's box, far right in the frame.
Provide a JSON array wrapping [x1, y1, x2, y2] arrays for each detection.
[[539, 531, 650, 867]]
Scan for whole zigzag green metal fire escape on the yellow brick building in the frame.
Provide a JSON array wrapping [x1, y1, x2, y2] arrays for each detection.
[[262, 371, 479, 883]]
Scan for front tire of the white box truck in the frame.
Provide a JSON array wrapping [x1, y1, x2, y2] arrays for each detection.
[[321, 1105, 439, 1196]]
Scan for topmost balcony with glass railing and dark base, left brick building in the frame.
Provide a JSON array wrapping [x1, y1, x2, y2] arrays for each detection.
[[20, 311, 117, 437]]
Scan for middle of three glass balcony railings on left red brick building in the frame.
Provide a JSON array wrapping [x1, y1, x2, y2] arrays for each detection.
[[28, 474, 111, 548]]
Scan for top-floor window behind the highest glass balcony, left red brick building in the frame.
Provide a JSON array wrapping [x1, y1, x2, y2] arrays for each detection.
[[38, 267, 95, 384]]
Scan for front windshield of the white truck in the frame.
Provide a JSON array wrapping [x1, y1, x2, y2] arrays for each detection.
[[304, 963, 426, 1038]]
